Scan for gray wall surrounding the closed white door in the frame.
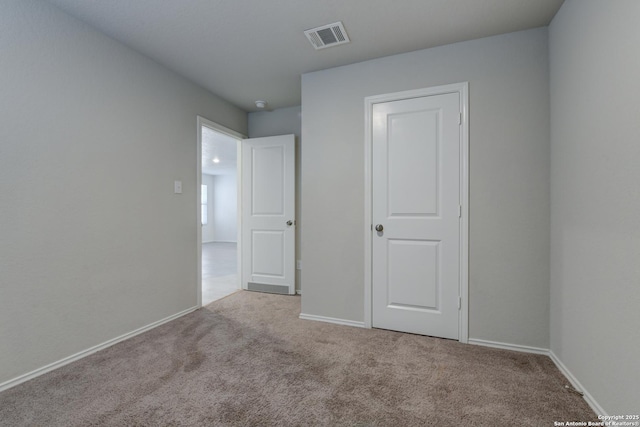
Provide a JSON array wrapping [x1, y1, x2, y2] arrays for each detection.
[[302, 28, 549, 348]]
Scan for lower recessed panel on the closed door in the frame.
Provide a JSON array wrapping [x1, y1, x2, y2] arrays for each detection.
[[387, 239, 440, 310]]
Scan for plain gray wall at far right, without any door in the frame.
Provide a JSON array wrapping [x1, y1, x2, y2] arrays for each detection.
[[549, 0, 640, 414]]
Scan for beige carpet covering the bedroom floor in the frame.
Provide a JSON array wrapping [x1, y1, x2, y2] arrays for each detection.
[[0, 292, 597, 427]]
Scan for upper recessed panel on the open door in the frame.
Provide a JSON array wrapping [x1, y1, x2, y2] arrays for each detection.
[[251, 146, 284, 215]]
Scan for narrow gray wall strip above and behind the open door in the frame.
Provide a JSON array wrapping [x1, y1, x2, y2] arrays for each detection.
[[248, 106, 304, 290]]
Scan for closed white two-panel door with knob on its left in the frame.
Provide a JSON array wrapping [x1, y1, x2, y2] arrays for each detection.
[[372, 93, 461, 339]]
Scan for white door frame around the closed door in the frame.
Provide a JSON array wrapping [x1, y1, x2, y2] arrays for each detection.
[[364, 82, 469, 343]]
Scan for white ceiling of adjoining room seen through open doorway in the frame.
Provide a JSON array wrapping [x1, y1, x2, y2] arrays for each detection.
[[202, 126, 238, 175]]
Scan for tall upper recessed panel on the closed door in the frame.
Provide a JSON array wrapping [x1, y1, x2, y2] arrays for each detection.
[[387, 110, 440, 216]]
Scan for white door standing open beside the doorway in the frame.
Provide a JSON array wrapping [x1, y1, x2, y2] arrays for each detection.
[[242, 135, 295, 294]]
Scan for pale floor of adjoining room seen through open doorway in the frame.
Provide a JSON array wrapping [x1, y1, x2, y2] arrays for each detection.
[[202, 242, 240, 306]]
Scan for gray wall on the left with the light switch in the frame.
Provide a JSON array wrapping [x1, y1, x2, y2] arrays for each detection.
[[0, 0, 247, 383]]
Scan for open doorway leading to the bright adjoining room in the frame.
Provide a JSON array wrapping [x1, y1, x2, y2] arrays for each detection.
[[197, 117, 244, 306]]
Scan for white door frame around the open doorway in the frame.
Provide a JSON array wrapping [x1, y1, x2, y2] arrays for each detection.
[[196, 116, 247, 308]]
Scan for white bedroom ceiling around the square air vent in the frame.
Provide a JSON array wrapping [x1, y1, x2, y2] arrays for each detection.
[[46, 0, 563, 111]]
